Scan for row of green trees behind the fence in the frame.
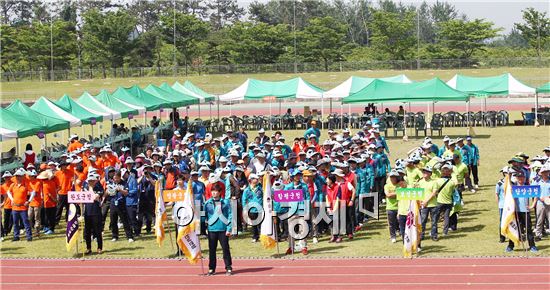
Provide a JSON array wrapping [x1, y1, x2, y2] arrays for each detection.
[[0, 0, 550, 76]]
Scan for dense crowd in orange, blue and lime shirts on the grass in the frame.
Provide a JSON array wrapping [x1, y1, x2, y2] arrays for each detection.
[[1, 113, 550, 255]]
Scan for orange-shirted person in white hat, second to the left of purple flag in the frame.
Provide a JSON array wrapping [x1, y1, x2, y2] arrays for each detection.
[[36, 170, 58, 235]]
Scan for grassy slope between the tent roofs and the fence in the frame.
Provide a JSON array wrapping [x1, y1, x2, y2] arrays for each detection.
[[0, 68, 550, 102]]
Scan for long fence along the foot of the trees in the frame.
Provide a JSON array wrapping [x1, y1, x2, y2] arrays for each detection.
[[0, 57, 550, 82]]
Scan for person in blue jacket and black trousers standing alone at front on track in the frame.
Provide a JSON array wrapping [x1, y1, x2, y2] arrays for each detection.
[[204, 184, 233, 276]]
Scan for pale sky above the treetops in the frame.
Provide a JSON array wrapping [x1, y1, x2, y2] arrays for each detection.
[[237, 0, 550, 33]]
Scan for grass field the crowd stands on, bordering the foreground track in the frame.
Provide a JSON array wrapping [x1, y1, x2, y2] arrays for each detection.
[[0, 127, 550, 258]]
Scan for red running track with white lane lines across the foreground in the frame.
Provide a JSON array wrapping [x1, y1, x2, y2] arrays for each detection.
[[0, 257, 550, 290]]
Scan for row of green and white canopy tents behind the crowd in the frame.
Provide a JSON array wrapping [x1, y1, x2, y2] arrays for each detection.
[[0, 74, 550, 141]]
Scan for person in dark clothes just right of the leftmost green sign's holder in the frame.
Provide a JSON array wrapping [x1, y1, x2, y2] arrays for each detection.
[[107, 168, 137, 243]]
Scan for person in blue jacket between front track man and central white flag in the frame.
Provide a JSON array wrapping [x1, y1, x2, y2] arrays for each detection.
[[242, 173, 263, 243]]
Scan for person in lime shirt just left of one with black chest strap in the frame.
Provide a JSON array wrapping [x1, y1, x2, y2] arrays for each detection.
[[416, 166, 438, 240]]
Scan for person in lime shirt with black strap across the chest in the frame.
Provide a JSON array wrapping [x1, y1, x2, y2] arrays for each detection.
[[432, 163, 456, 241]]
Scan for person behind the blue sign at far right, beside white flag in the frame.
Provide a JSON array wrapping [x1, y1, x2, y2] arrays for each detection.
[[506, 171, 538, 253]]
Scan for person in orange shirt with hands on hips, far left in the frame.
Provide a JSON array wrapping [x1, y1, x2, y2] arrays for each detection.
[[8, 168, 35, 242]]
